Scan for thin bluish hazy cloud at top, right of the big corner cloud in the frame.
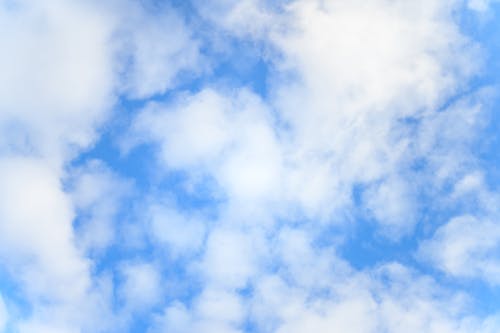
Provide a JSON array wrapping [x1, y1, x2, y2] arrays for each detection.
[[112, 1, 206, 98]]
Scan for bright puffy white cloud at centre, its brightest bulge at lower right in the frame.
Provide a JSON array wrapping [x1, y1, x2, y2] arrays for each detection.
[[129, 89, 281, 201]]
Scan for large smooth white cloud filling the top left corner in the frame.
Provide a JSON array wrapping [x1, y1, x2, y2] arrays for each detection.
[[0, 0, 114, 162]]
